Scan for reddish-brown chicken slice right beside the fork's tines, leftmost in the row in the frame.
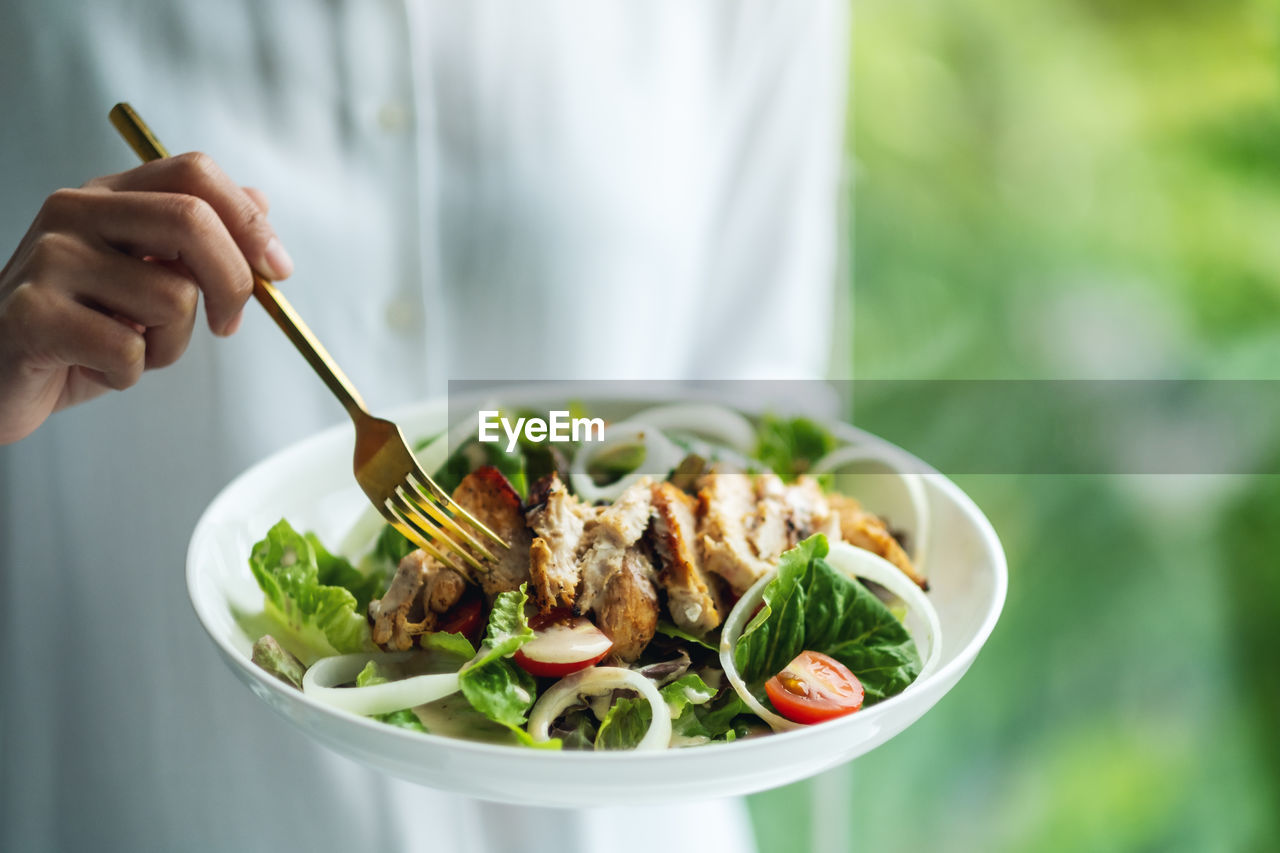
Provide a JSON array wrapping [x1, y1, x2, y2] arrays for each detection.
[[453, 465, 534, 601]]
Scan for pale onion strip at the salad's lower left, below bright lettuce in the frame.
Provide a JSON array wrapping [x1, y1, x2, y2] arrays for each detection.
[[302, 652, 460, 717]]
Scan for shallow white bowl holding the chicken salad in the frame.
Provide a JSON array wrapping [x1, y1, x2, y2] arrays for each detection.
[[187, 392, 1007, 806]]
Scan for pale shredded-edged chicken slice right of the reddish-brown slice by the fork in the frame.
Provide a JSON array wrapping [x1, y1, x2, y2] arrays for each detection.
[[525, 473, 595, 612]]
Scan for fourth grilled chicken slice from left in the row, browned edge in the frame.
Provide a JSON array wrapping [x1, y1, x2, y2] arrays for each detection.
[[653, 483, 723, 635]]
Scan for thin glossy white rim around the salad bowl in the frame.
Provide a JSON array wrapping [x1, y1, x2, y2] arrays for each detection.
[[184, 384, 1009, 765]]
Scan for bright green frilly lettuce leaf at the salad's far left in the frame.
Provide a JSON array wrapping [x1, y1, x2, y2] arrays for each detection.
[[248, 520, 374, 650]]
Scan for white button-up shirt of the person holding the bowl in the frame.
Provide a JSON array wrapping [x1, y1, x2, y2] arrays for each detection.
[[0, 0, 849, 853]]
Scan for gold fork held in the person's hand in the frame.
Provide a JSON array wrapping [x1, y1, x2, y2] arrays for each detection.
[[110, 104, 507, 574]]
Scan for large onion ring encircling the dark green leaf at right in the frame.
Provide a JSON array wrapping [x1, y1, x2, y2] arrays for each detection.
[[719, 542, 942, 731]]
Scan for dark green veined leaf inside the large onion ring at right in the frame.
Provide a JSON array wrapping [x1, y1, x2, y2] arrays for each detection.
[[733, 533, 920, 704]]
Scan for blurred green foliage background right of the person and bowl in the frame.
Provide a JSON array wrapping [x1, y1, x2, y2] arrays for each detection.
[[750, 0, 1280, 853]]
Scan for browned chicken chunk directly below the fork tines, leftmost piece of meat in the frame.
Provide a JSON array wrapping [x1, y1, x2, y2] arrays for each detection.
[[369, 549, 467, 652]]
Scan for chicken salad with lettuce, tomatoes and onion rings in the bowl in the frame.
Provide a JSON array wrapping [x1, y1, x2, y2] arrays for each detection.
[[250, 405, 940, 751]]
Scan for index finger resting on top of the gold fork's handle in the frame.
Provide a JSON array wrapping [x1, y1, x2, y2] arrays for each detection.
[[86, 151, 293, 279]]
